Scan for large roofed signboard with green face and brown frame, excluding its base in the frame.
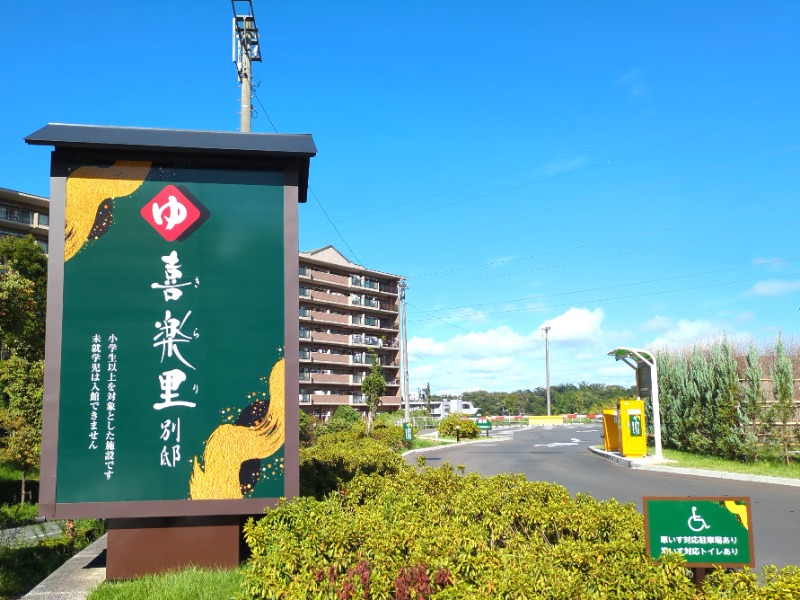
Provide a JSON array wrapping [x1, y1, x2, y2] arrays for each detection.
[[26, 125, 315, 519]]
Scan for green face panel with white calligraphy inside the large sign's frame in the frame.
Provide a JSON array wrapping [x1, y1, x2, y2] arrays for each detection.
[[56, 162, 284, 503]]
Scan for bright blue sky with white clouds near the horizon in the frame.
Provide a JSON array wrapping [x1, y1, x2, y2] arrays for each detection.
[[0, 0, 800, 393]]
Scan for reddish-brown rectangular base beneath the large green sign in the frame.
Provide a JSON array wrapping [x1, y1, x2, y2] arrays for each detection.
[[106, 515, 244, 580]]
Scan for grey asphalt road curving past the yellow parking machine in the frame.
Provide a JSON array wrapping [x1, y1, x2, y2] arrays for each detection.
[[407, 425, 800, 570]]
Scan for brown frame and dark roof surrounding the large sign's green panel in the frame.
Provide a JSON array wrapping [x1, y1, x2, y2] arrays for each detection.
[[25, 125, 316, 519]]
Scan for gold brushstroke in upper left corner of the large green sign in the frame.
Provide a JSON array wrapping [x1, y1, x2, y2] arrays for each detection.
[[64, 160, 151, 262]]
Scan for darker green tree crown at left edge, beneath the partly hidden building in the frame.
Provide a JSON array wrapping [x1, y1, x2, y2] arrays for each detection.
[[0, 236, 47, 361]]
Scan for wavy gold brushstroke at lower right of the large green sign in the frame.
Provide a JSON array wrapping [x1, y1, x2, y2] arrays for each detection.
[[189, 358, 286, 500]]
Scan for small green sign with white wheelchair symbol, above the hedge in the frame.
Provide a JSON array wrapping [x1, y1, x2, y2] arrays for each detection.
[[643, 496, 755, 567]]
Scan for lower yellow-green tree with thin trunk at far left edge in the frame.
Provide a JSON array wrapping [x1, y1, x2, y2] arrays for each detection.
[[0, 356, 44, 503]]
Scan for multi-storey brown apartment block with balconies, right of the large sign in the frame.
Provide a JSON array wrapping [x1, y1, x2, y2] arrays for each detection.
[[300, 246, 402, 419]]
